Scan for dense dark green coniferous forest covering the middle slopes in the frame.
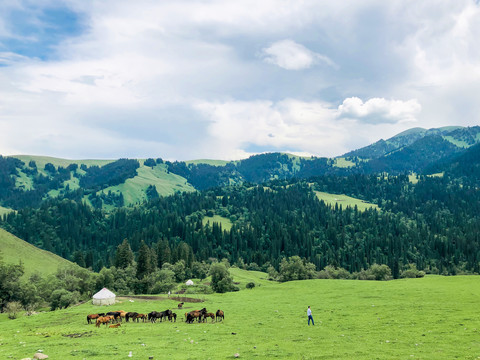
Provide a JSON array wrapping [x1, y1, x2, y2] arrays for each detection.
[[2, 173, 480, 278]]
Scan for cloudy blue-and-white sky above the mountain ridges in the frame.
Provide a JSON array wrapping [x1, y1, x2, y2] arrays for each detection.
[[0, 0, 480, 160]]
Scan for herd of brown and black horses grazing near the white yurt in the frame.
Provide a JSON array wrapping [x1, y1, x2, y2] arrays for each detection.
[[87, 303, 225, 328]]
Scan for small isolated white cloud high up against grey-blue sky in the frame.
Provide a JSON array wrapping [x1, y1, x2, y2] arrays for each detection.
[[262, 39, 336, 70]]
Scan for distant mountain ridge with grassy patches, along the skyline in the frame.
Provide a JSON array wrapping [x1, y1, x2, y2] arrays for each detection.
[[0, 126, 480, 211]]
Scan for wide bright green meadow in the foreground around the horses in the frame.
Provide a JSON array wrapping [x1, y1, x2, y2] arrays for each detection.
[[0, 269, 480, 360]]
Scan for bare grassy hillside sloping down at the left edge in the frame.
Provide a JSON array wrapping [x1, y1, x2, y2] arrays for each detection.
[[0, 229, 71, 278]]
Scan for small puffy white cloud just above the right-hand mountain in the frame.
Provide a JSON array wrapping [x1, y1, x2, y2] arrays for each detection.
[[338, 97, 422, 124]]
